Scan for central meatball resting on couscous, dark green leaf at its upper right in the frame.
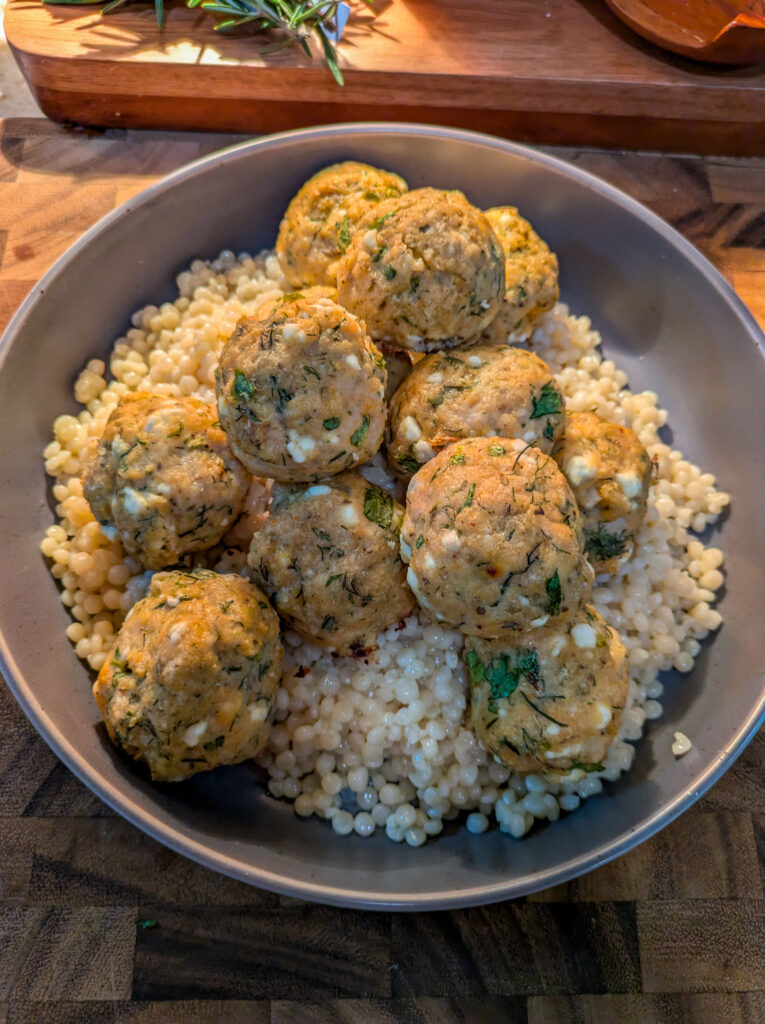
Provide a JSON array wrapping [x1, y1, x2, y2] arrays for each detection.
[[248, 472, 415, 654]]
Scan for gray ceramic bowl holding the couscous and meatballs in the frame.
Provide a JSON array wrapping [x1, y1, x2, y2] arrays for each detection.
[[0, 125, 765, 908]]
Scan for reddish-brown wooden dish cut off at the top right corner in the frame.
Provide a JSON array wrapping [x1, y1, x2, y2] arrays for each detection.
[[605, 0, 765, 65]]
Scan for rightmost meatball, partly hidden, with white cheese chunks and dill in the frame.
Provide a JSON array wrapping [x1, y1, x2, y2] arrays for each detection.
[[553, 413, 650, 572]]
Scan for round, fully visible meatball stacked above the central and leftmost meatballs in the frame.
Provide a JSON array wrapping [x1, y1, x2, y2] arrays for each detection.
[[215, 299, 386, 482]]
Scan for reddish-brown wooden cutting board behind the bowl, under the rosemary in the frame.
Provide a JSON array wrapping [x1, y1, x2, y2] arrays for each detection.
[[5, 0, 765, 156]]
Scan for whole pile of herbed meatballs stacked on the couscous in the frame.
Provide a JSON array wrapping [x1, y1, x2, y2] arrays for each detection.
[[84, 163, 650, 794]]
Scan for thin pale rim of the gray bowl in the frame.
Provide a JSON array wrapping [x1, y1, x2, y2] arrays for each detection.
[[0, 122, 765, 910]]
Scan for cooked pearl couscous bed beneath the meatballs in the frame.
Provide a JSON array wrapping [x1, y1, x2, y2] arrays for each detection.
[[41, 243, 729, 846]]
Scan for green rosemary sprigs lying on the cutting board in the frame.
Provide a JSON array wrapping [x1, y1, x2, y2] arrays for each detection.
[[43, 0, 360, 85]]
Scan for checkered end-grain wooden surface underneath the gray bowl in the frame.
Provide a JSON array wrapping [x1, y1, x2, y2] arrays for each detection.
[[0, 120, 765, 1024]]
